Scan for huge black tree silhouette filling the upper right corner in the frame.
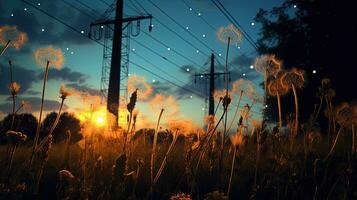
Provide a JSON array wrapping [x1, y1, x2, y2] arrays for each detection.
[[255, 0, 357, 124]]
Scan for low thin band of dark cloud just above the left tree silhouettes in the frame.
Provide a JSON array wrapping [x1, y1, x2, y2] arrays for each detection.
[[0, 97, 68, 113]]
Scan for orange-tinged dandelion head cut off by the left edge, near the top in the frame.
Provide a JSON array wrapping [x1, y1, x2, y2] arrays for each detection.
[[0, 26, 28, 49]]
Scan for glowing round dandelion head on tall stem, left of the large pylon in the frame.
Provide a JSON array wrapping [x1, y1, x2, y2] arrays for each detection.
[[34, 46, 64, 69]]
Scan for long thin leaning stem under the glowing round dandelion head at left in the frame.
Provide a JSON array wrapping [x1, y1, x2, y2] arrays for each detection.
[[29, 61, 50, 169]]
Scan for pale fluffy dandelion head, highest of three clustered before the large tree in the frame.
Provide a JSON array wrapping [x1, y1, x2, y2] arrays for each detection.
[[254, 55, 282, 78]]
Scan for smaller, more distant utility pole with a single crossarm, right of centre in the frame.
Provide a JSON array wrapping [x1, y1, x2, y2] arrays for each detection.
[[195, 53, 230, 115]]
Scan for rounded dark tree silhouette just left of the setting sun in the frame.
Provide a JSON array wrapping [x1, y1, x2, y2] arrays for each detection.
[[41, 112, 83, 143]]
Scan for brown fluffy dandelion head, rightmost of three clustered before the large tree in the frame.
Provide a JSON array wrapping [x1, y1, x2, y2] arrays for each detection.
[[280, 68, 305, 88]]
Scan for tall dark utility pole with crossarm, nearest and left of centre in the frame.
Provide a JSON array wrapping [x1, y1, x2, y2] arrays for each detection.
[[91, 0, 152, 128]]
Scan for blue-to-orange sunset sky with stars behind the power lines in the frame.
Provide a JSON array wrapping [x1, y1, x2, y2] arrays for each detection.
[[0, 0, 283, 125]]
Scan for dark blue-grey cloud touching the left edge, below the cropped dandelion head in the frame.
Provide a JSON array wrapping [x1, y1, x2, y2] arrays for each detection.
[[0, 63, 37, 95]]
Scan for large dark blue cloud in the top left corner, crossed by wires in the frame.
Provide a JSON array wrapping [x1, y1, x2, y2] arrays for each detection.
[[0, 0, 93, 48]]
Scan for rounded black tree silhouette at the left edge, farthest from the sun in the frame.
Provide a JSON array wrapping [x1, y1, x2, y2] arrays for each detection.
[[0, 113, 37, 142]]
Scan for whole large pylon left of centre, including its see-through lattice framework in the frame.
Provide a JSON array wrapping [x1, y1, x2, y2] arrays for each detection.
[[90, 0, 153, 128]]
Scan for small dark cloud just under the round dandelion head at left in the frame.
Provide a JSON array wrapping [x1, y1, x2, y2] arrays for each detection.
[[38, 67, 88, 84]]
